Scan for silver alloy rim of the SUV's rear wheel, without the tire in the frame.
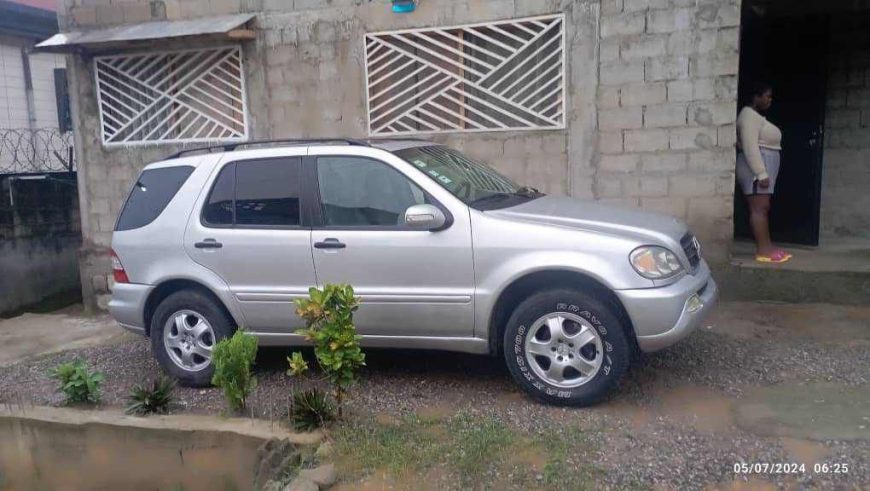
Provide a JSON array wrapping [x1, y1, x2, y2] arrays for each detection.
[[163, 310, 215, 372]]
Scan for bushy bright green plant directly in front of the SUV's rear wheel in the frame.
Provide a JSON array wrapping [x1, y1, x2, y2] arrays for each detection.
[[211, 329, 257, 411]]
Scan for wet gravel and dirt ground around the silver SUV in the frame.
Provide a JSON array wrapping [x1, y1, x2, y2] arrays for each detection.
[[0, 302, 870, 489]]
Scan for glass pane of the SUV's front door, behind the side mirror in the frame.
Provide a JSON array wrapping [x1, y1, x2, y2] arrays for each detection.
[[317, 157, 426, 226]]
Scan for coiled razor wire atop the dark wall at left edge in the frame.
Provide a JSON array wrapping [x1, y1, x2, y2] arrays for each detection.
[[0, 128, 75, 175]]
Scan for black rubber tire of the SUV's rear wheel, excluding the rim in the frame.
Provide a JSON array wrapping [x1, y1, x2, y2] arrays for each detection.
[[150, 290, 236, 387]]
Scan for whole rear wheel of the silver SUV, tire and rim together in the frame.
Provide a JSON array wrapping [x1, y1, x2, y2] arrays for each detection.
[[151, 290, 235, 387]]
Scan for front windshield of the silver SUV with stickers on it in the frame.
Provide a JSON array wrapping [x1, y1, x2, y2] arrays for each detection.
[[395, 145, 543, 210]]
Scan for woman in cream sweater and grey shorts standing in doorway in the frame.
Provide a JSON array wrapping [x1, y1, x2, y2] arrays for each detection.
[[737, 83, 792, 263]]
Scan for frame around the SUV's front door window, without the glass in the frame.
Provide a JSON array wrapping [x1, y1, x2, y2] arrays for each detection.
[[303, 153, 453, 232]]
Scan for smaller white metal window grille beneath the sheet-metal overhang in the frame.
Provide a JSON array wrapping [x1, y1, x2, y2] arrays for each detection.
[[94, 46, 248, 146]]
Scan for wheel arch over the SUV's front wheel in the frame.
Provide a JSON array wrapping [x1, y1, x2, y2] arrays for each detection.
[[488, 269, 638, 356]]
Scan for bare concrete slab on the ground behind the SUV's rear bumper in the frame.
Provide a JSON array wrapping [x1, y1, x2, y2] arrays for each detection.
[[0, 305, 135, 366]]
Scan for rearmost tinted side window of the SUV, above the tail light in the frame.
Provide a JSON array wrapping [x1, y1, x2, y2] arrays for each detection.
[[115, 166, 193, 231]]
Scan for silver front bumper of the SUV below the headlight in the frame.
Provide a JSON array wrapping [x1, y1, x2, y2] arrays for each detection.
[[616, 260, 719, 353]]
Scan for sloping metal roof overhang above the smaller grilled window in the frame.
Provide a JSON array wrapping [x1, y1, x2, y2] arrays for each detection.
[[36, 14, 256, 52]]
